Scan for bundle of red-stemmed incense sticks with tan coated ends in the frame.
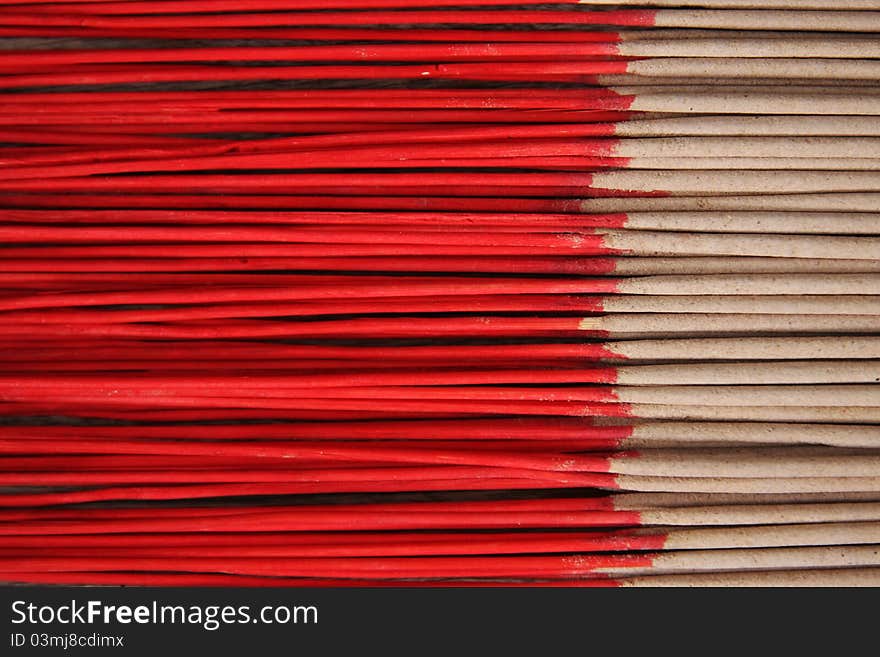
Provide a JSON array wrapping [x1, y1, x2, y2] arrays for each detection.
[[0, 0, 880, 587]]
